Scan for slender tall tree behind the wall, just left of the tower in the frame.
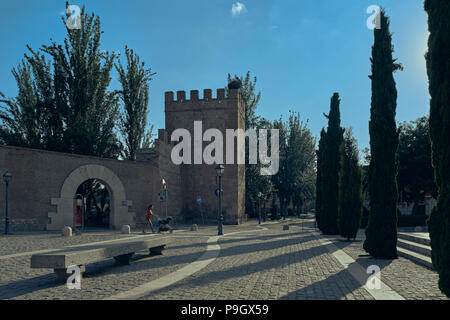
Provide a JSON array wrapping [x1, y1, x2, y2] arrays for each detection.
[[115, 46, 156, 160]]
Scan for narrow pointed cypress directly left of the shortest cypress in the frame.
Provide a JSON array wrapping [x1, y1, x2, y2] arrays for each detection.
[[321, 93, 343, 235]]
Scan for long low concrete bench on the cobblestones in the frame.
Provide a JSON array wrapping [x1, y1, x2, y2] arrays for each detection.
[[31, 235, 173, 281]]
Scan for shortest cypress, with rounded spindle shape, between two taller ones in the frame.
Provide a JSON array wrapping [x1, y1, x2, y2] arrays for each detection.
[[338, 129, 362, 241]]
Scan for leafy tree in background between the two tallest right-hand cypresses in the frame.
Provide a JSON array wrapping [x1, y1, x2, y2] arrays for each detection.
[[397, 117, 437, 202]]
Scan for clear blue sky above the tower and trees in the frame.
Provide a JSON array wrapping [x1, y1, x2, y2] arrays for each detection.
[[0, 0, 429, 149]]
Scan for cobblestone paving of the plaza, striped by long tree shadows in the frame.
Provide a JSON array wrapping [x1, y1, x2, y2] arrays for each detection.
[[0, 219, 445, 300]]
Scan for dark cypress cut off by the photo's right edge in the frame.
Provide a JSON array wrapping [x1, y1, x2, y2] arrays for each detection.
[[425, 0, 450, 297]]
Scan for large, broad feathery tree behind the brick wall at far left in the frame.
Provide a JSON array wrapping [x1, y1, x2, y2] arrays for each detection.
[[0, 3, 120, 158]]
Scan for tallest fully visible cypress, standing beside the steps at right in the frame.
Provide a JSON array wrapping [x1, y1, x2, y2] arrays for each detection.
[[364, 10, 402, 259]]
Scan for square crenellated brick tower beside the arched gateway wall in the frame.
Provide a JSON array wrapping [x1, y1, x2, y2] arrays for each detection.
[[165, 88, 245, 224]]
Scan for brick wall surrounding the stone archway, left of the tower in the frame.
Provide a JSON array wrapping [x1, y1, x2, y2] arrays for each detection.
[[0, 146, 181, 231]]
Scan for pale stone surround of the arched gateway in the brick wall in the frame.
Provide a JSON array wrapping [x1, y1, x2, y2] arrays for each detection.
[[47, 164, 135, 230]]
